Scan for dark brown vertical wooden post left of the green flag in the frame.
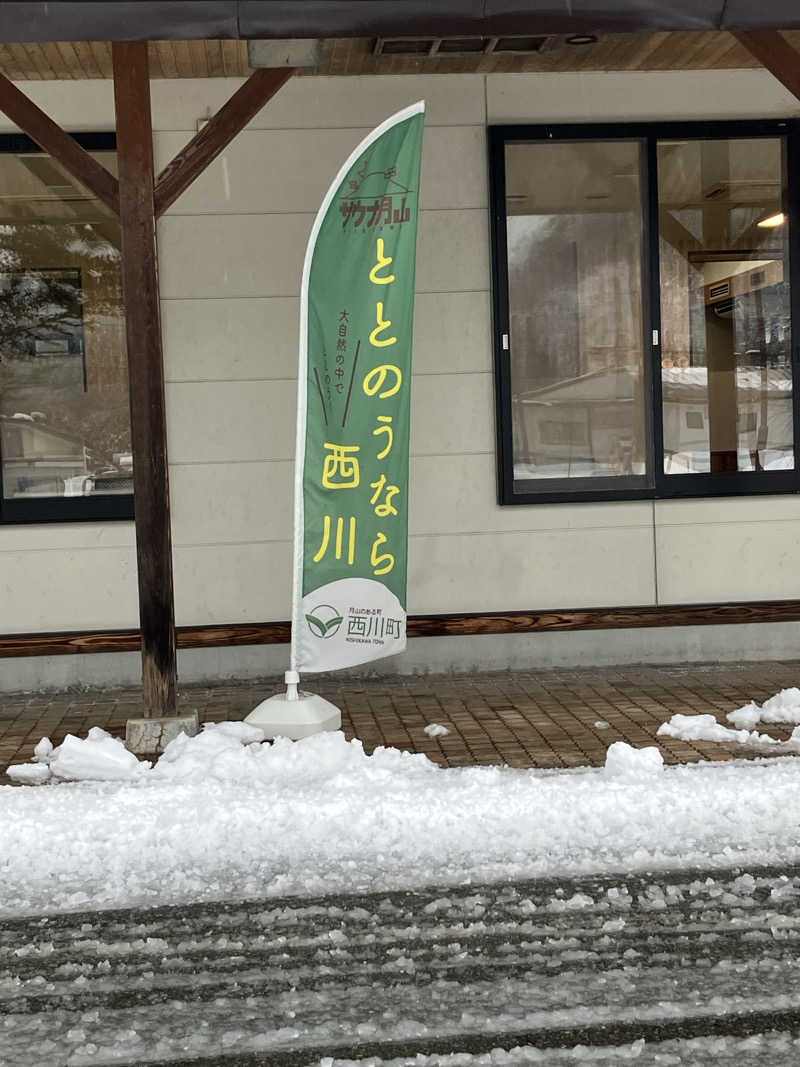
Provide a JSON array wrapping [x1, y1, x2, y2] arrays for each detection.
[[112, 42, 177, 716]]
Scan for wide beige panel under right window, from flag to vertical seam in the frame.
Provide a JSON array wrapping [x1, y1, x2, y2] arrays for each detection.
[[409, 527, 655, 614]]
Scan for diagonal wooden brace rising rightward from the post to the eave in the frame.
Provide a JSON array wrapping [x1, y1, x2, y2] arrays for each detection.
[[156, 67, 292, 218]]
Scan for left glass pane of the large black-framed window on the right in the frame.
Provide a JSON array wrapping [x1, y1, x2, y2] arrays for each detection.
[[506, 141, 646, 492]]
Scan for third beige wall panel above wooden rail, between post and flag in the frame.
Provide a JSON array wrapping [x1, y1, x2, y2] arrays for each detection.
[[166, 382, 297, 464]]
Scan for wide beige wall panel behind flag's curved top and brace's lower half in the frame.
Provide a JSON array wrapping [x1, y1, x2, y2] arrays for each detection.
[[155, 126, 487, 214]]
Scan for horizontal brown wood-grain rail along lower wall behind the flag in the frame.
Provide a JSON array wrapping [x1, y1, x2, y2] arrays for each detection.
[[0, 601, 800, 658]]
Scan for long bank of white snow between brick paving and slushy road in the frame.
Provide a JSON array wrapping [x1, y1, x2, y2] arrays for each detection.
[[0, 723, 800, 915]]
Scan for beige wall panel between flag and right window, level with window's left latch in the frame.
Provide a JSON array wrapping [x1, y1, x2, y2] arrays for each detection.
[[414, 292, 493, 375]]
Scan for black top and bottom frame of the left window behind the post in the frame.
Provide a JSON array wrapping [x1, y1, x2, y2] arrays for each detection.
[[0, 131, 133, 526]]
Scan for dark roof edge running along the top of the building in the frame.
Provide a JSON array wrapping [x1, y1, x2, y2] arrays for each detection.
[[0, 0, 800, 43]]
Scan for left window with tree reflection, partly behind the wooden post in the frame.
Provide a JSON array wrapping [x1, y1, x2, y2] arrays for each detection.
[[0, 133, 133, 523]]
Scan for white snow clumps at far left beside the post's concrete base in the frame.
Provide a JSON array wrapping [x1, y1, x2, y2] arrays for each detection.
[[6, 727, 150, 783]]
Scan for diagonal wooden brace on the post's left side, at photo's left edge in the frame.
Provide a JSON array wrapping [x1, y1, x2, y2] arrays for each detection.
[[0, 74, 119, 214]]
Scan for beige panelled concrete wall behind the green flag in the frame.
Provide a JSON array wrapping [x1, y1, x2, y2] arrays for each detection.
[[0, 71, 800, 682]]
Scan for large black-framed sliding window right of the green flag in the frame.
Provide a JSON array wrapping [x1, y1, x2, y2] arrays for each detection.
[[490, 121, 800, 504]]
